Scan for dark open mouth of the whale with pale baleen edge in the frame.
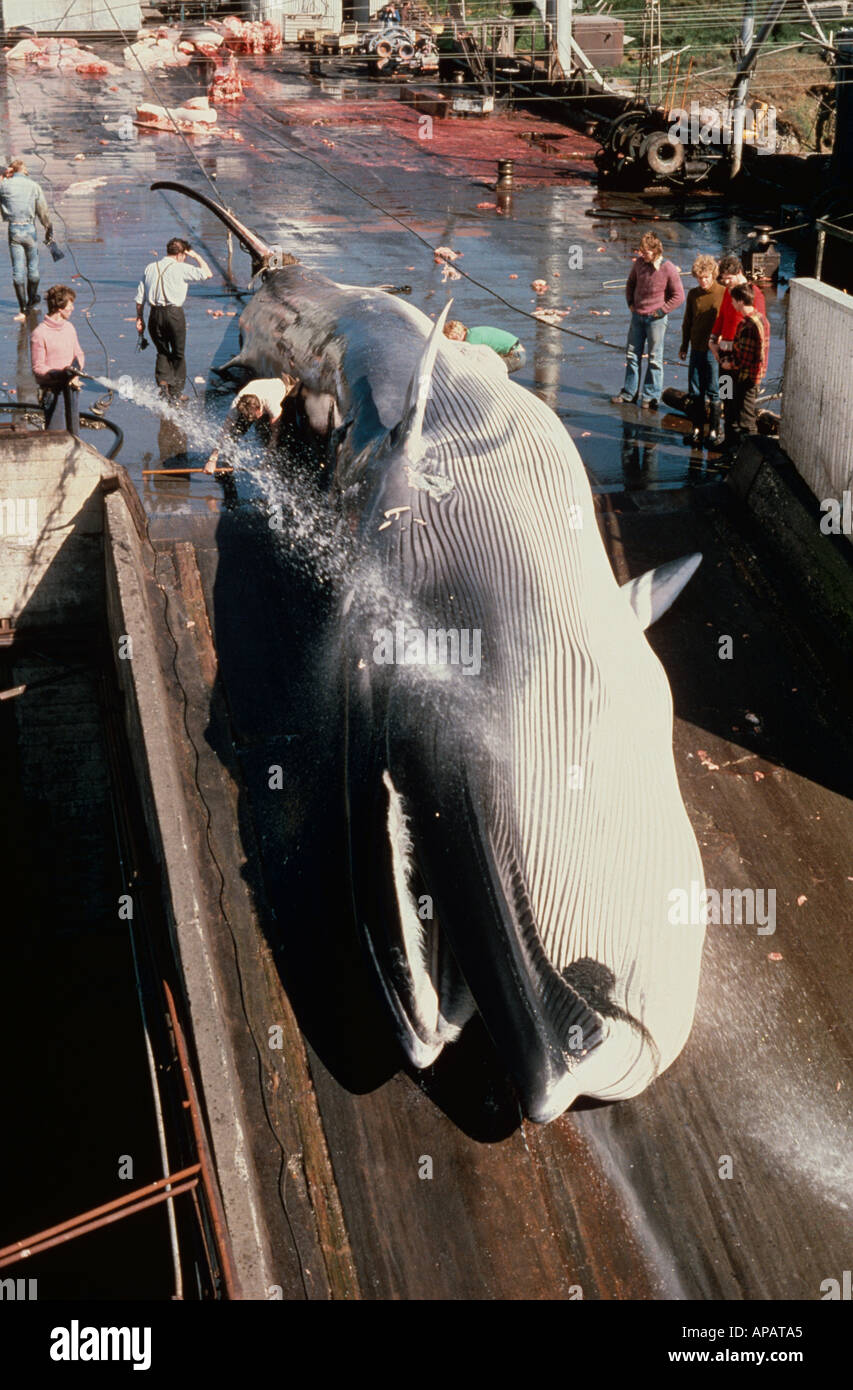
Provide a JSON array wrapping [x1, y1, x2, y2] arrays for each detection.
[[353, 711, 613, 1123]]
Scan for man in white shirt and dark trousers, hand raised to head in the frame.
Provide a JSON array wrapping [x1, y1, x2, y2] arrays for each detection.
[[136, 236, 213, 400]]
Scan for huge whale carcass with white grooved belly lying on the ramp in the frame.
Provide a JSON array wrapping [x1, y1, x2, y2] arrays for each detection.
[[160, 185, 704, 1122]]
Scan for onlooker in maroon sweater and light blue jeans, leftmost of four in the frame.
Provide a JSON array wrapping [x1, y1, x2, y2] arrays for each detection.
[[610, 232, 684, 410]]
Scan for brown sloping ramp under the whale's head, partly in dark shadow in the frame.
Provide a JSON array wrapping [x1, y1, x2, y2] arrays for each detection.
[[157, 489, 853, 1300]]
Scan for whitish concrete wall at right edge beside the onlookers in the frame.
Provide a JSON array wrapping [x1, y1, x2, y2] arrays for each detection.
[[779, 279, 853, 542]]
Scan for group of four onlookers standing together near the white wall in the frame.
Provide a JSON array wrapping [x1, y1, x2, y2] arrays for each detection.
[[611, 232, 770, 450]]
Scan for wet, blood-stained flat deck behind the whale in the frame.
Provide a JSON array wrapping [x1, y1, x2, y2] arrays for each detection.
[[0, 53, 793, 497]]
